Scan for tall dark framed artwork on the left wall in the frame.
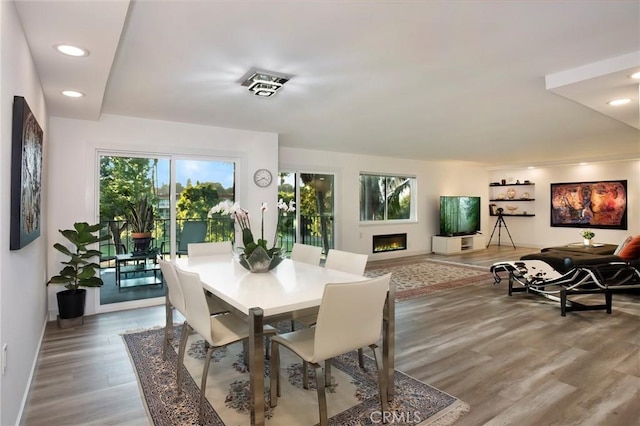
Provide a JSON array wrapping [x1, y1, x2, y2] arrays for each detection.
[[9, 96, 43, 250]]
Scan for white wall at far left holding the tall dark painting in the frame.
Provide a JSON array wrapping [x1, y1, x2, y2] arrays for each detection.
[[0, 1, 49, 425]]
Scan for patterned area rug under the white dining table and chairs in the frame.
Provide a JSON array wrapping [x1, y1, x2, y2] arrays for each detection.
[[123, 326, 469, 426]]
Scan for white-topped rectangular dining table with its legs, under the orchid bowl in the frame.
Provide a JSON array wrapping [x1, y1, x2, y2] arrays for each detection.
[[176, 255, 395, 425]]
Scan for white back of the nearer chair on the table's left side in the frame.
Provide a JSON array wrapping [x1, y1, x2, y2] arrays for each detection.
[[176, 267, 211, 340]]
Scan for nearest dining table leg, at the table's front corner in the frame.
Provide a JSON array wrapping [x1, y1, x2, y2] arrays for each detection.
[[249, 308, 265, 426]]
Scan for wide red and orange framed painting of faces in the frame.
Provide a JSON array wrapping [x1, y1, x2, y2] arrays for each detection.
[[551, 180, 627, 229]]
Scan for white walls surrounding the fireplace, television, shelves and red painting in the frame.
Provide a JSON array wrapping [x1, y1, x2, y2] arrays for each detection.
[[280, 147, 640, 260]]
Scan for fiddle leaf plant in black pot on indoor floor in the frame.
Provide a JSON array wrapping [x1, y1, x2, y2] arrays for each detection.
[[47, 222, 111, 323]]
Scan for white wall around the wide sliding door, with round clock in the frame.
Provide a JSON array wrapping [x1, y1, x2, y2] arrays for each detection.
[[47, 115, 278, 318]]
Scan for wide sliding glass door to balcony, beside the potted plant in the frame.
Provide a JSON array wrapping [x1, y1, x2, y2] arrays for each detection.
[[98, 153, 236, 305]]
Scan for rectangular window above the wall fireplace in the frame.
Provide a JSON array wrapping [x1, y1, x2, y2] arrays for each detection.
[[360, 173, 416, 222]]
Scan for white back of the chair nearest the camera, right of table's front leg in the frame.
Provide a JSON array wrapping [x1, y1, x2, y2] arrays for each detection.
[[310, 274, 391, 362]]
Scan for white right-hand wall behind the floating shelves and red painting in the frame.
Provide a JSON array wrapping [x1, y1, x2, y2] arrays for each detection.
[[489, 159, 640, 247]]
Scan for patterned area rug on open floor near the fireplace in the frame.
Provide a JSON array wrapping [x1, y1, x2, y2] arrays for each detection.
[[365, 259, 493, 301]]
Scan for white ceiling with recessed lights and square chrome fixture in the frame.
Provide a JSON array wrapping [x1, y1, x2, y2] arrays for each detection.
[[11, 0, 640, 167]]
